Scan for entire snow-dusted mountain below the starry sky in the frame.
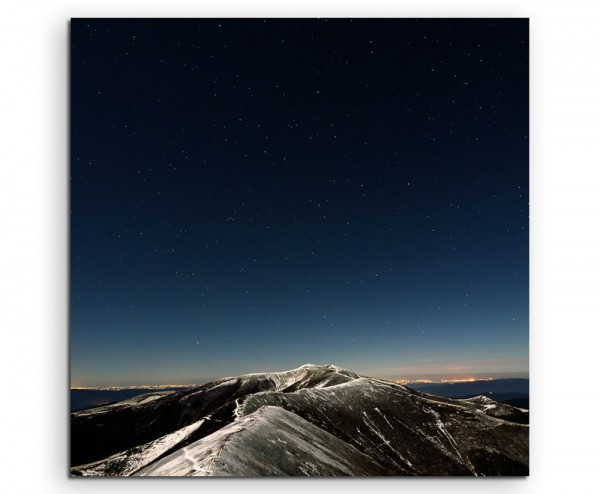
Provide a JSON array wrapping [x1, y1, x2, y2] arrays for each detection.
[[71, 364, 529, 477]]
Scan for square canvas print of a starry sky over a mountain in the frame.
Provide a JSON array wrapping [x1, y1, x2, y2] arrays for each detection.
[[69, 18, 529, 477]]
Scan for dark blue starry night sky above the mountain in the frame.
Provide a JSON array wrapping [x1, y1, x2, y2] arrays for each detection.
[[70, 19, 529, 386]]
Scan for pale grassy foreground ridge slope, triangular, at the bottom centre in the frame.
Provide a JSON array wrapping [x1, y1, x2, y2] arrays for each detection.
[[136, 406, 393, 477]]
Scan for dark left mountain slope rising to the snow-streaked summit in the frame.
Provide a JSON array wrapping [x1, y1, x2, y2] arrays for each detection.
[[71, 365, 358, 465]]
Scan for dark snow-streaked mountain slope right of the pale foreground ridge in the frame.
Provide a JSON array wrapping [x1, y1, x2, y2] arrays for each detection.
[[243, 378, 528, 475]]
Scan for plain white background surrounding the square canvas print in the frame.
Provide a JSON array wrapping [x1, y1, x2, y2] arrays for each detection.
[[0, 0, 600, 493]]
